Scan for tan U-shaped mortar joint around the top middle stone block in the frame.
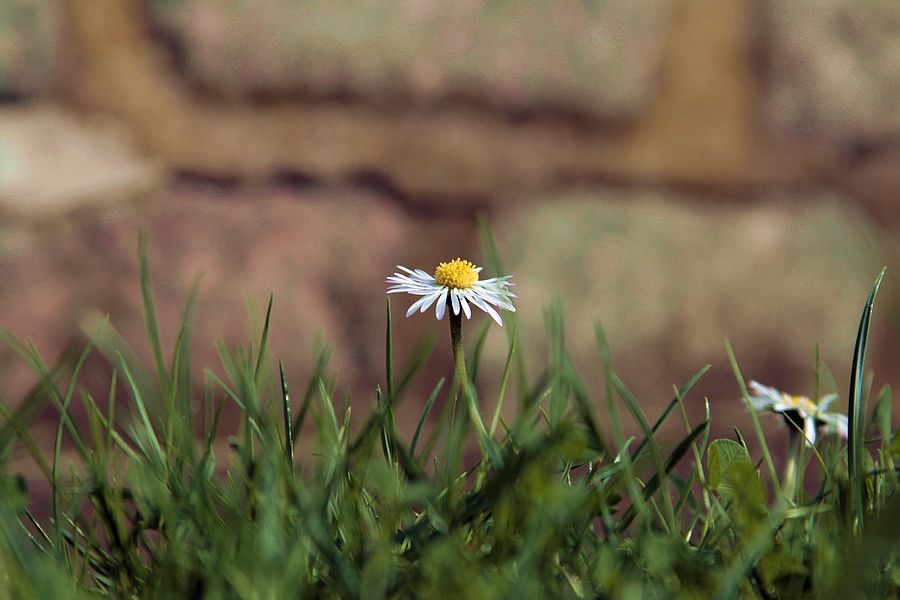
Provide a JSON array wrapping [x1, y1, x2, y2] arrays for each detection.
[[49, 0, 808, 207]]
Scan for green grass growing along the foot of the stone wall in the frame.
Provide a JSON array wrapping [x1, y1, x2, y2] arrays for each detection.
[[0, 241, 900, 599]]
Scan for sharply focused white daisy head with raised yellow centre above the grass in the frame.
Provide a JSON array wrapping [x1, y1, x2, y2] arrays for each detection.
[[386, 258, 518, 326]]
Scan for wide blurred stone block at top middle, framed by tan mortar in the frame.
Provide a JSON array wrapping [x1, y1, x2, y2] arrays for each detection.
[[150, 0, 673, 118]]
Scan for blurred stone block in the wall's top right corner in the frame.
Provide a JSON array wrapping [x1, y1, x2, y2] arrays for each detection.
[[766, 0, 900, 142]]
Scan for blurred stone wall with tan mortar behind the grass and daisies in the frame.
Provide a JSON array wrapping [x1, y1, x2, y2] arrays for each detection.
[[0, 0, 900, 462]]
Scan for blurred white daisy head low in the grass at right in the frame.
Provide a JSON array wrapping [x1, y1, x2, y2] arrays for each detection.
[[750, 381, 848, 445]]
